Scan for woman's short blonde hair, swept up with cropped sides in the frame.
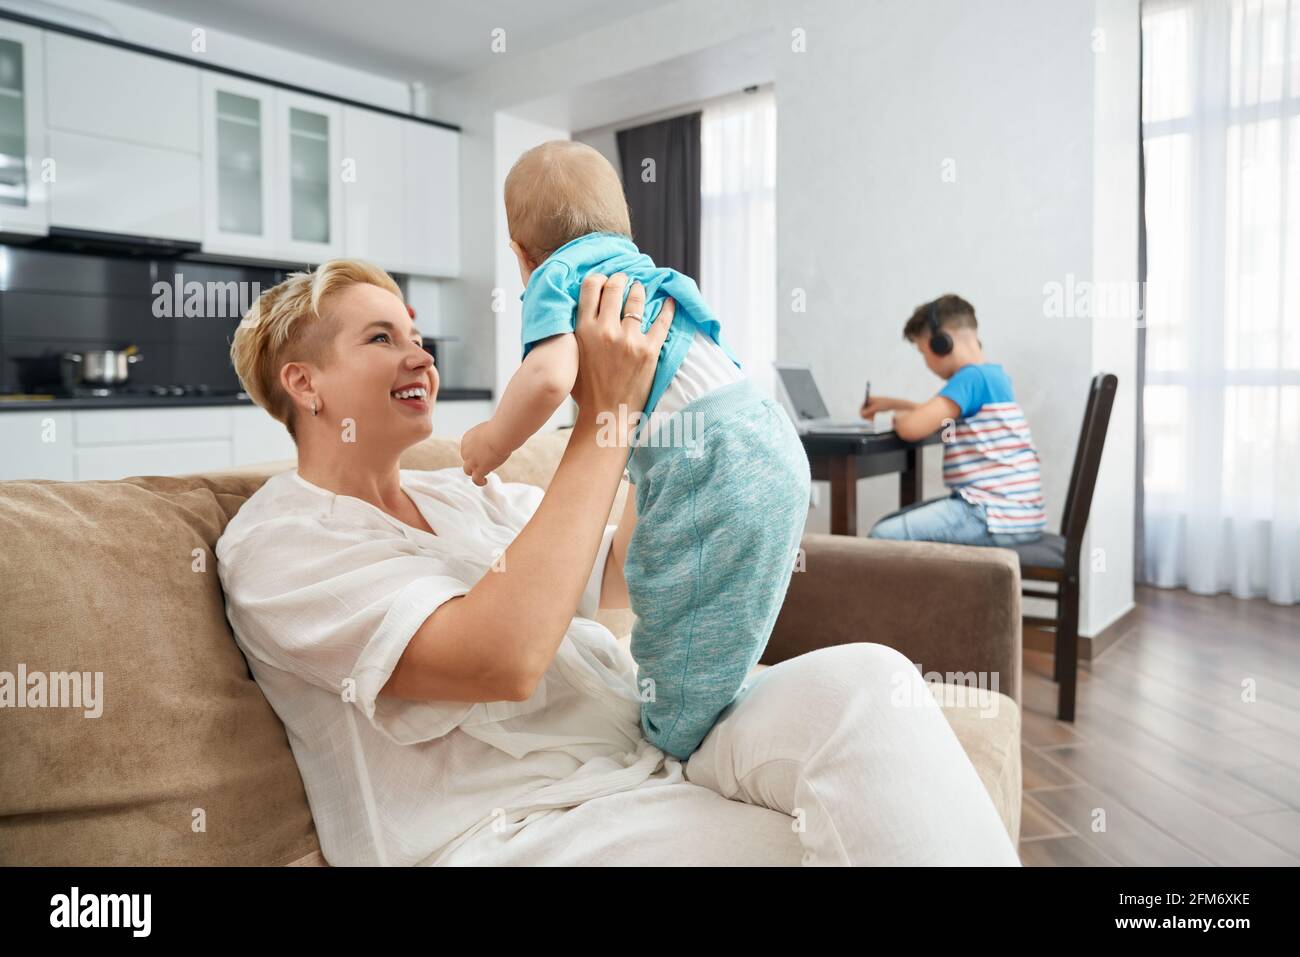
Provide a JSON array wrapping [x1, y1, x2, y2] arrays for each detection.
[[230, 259, 404, 442]]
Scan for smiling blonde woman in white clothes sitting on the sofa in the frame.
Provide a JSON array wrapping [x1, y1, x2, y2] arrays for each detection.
[[216, 260, 1019, 866]]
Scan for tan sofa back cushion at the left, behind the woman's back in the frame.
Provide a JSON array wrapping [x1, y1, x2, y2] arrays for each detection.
[[0, 477, 319, 865]]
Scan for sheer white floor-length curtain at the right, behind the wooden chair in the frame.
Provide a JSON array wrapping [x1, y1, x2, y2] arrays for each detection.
[[1143, 0, 1300, 603]]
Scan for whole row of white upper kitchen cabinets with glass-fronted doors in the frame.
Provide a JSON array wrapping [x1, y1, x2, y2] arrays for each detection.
[[0, 21, 460, 269]]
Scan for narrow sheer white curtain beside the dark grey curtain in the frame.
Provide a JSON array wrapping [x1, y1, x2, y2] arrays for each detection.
[[699, 88, 776, 395]]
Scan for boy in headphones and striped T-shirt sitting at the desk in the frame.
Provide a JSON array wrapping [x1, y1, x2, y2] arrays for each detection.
[[861, 294, 1047, 547]]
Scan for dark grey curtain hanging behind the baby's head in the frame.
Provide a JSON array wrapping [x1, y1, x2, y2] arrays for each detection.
[[618, 112, 699, 282]]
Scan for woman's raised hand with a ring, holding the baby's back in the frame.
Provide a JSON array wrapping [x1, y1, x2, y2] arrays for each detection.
[[572, 273, 676, 445]]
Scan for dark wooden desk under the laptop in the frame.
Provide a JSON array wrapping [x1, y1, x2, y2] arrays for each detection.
[[802, 432, 941, 534]]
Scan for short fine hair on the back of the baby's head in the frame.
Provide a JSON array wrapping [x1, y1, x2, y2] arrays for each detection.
[[506, 139, 632, 265]]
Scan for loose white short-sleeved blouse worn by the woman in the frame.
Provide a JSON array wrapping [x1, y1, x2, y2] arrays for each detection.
[[216, 467, 681, 865]]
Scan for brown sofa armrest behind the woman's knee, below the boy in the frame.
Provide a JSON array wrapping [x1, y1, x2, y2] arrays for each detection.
[[762, 533, 1021, 705]]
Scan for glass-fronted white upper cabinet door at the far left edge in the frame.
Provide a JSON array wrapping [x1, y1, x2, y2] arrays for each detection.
[[0, 21, 49, 235]]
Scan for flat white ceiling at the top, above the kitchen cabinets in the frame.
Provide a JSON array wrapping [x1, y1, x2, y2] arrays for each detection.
[[111, 0, 671, 82]]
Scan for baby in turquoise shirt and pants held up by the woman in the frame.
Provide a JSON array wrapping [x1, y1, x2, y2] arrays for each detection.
[[460, 140, 811, 759]]
